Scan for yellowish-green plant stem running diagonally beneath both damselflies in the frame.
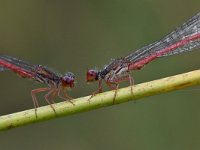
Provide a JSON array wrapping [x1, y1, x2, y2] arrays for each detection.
[[0, 70, 200, 130]]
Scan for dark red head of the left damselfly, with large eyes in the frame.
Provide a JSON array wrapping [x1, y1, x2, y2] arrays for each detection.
[[62, 72, 75, 88]]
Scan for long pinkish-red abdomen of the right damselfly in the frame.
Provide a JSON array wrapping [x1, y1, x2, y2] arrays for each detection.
[[128, 33, 200, 70]]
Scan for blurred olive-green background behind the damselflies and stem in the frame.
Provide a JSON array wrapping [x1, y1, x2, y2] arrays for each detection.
[[0, 0, 200, 150]]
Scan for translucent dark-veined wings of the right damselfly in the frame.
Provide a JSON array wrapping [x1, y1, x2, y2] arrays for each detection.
[[125, 13, 200, 63]]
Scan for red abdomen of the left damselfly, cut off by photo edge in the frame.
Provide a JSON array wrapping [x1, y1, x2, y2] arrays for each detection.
[[0, 59, 33, 78]]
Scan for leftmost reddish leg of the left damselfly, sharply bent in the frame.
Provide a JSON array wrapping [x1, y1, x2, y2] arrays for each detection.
[[31, 88, 50, 117]]
